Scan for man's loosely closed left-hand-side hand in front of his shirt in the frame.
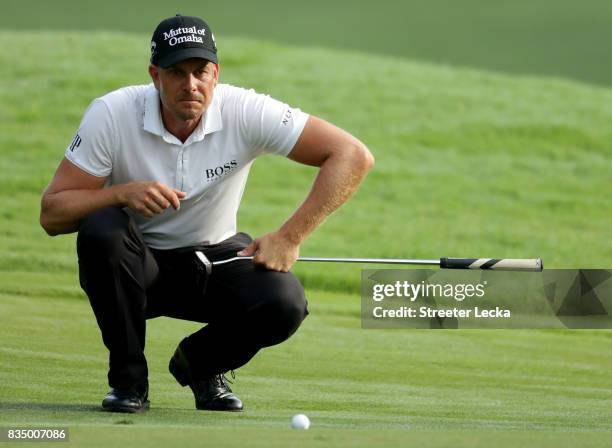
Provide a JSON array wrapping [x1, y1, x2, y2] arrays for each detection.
[[118, 182, 186, 218]]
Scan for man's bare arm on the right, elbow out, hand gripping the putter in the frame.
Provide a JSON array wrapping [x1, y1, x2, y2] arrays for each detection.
[[238, 117, 374, 272]]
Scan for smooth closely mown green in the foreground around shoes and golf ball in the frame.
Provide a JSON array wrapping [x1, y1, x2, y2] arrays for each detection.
[[0, 291, 612, 447]]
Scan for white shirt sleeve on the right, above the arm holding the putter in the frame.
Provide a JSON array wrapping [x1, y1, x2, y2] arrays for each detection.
[[235, 90, 309, 156]]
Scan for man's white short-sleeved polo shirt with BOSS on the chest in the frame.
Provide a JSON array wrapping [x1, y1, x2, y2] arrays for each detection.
[[65, 84, 308, 249]]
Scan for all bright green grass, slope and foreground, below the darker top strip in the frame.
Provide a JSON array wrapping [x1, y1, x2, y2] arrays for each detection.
[[0, 32, 612, 447]]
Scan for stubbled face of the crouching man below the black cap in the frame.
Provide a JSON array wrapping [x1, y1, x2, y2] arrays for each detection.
[[149, 58, 219, 122]]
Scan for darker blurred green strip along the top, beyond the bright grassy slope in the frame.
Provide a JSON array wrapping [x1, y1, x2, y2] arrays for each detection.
[[0, 0, 612, 85]]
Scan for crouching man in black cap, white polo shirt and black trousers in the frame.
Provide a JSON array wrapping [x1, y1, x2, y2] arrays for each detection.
[[41, 15, 373, 412]]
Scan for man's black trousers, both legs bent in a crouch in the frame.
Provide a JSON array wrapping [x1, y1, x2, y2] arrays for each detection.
[[77, 207, 308, 389]]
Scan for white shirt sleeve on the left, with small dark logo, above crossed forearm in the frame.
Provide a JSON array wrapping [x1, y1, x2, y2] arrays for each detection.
[[64, 99, 115, 177]]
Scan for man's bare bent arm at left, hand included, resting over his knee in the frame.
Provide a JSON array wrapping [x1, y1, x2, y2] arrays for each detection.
[[40, 159, 185, 236]]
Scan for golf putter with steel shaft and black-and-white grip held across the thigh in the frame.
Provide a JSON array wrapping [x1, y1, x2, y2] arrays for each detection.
[[196, 254, 544, 274]]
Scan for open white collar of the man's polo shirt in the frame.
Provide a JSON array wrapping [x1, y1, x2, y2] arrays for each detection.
[[143, 84, 223, 145]]
